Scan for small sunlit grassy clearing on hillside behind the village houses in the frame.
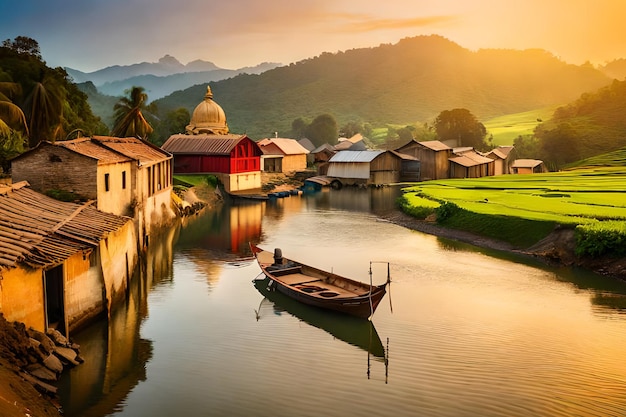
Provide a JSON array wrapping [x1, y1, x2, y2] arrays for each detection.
[[483, 106, 559, 146]]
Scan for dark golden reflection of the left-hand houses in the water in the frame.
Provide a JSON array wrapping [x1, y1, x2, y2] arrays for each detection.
[[59, 224, 178, 416]]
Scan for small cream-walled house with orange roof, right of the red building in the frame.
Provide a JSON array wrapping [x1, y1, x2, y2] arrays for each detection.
[[257, 138, 309, 173]]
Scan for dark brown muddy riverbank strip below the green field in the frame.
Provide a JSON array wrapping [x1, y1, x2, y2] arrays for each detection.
[[383, 210, 626, 281]]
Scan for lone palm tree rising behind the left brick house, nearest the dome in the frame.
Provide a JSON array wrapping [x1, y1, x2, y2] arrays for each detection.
[[111, 87, 154, 139]]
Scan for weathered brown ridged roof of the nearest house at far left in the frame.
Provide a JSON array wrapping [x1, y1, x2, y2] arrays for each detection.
[[0, 181, 131, 270]]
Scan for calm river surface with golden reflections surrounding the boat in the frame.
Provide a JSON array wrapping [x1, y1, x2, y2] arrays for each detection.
[[60, 189, 626, 417]]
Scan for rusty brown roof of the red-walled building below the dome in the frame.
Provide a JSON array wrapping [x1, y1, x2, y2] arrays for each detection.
[[161, 134, 247, 155]]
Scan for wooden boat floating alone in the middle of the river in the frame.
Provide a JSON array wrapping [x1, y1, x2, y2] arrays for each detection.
[[250, 243, 390, 318]]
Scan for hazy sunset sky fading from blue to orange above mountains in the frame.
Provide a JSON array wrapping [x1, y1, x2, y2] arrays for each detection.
[[0, 0, 626, 72]]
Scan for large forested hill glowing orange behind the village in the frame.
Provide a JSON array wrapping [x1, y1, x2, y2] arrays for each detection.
[[156, 35, 610, 138]]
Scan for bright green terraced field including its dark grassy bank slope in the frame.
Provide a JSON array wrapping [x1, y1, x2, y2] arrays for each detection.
[[403, 166, 626, 250]]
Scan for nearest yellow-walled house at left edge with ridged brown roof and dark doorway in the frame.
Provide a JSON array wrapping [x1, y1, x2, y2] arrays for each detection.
[[0, 181, 139, 336]]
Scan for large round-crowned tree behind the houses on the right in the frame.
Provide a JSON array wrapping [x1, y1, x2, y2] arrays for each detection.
[[434, 109, 487, 150]]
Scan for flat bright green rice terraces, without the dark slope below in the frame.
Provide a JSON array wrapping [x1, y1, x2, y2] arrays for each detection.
[[404, 167, 626, 224]]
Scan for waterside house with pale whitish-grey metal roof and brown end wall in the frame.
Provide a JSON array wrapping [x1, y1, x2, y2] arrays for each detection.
[[328, 150, 402, 187]]
